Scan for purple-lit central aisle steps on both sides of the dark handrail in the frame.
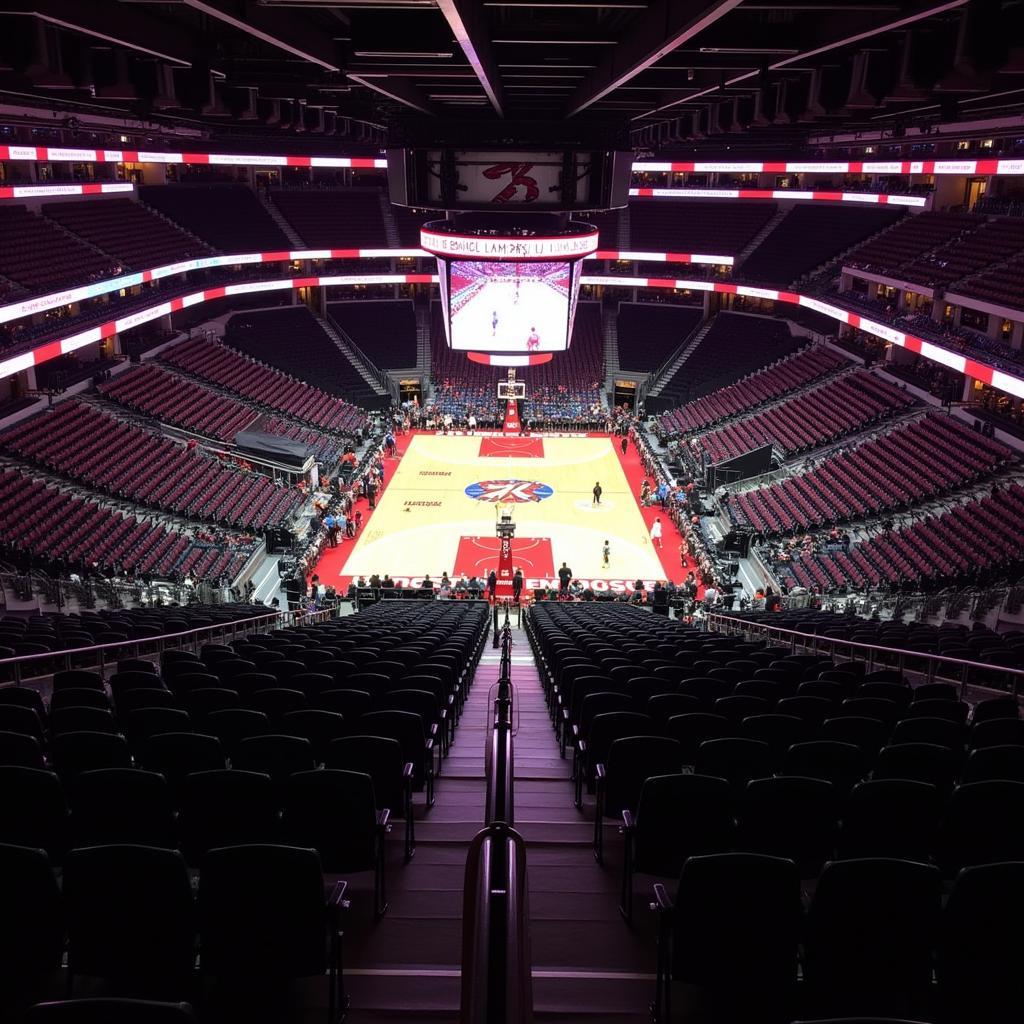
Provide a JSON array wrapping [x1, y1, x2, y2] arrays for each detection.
[[345, 629, 654, 1024]]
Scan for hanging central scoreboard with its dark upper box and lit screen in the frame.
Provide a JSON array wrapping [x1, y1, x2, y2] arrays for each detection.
[[388, 140, 633, 367]]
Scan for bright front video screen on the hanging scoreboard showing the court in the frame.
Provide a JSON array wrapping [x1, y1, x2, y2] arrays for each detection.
[[449, 260, 572, 355]]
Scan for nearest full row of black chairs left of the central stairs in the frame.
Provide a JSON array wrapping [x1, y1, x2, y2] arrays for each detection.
[[0, 844, 347, 1024]]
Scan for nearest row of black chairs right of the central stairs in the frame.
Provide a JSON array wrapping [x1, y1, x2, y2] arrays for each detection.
[[652, 853, 1024, 1024]]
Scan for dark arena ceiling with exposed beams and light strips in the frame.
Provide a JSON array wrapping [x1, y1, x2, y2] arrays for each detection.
[[0, 0, 1024, 152]]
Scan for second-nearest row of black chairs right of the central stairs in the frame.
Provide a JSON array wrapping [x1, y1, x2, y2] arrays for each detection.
[[614, 770, 1024, 919]]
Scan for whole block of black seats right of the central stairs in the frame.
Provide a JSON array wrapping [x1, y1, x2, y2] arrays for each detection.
[[528, 602, 1024, 1024]]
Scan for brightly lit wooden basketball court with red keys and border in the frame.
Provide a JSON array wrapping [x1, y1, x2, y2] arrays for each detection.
[[316, 433, 686, 592]]
